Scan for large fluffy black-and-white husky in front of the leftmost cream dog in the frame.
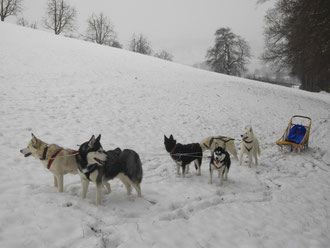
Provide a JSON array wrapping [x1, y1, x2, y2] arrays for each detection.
[[76, 135, 143, 205]]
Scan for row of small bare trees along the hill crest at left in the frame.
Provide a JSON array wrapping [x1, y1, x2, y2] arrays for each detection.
[[0, 0, 173, 61]]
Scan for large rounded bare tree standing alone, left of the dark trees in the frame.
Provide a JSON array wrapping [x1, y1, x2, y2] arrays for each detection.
[[206, 28, 251, 76]]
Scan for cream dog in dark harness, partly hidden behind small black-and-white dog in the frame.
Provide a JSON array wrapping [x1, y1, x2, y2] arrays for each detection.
[[200, 136, 238, 160]]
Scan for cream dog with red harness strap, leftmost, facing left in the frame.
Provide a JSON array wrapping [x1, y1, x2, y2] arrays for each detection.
[[20, 134, 78, 192]]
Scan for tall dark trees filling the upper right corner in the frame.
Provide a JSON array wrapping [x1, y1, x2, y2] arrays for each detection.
[[263, 0, 330, 92]]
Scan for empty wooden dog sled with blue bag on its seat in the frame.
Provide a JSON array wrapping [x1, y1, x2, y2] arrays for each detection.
[[276, 115, 312, 153]]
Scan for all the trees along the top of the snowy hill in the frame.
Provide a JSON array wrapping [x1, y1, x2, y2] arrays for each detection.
[[0, 0, 330, 92]]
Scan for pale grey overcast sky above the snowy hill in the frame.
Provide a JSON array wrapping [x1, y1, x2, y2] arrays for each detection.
[[11, 0, 274, 70]]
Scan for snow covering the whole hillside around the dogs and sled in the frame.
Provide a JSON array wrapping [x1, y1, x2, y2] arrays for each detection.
[[0, 23, 330, 248]]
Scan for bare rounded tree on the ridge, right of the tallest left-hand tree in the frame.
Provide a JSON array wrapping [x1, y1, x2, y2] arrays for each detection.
[[86, 13, 121, 48]]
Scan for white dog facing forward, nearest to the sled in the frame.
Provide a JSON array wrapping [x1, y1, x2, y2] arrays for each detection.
[[239, 126, 260, 168]]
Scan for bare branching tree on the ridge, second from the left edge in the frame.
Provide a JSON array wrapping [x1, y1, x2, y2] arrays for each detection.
[[44, 0, 77, 34]]
